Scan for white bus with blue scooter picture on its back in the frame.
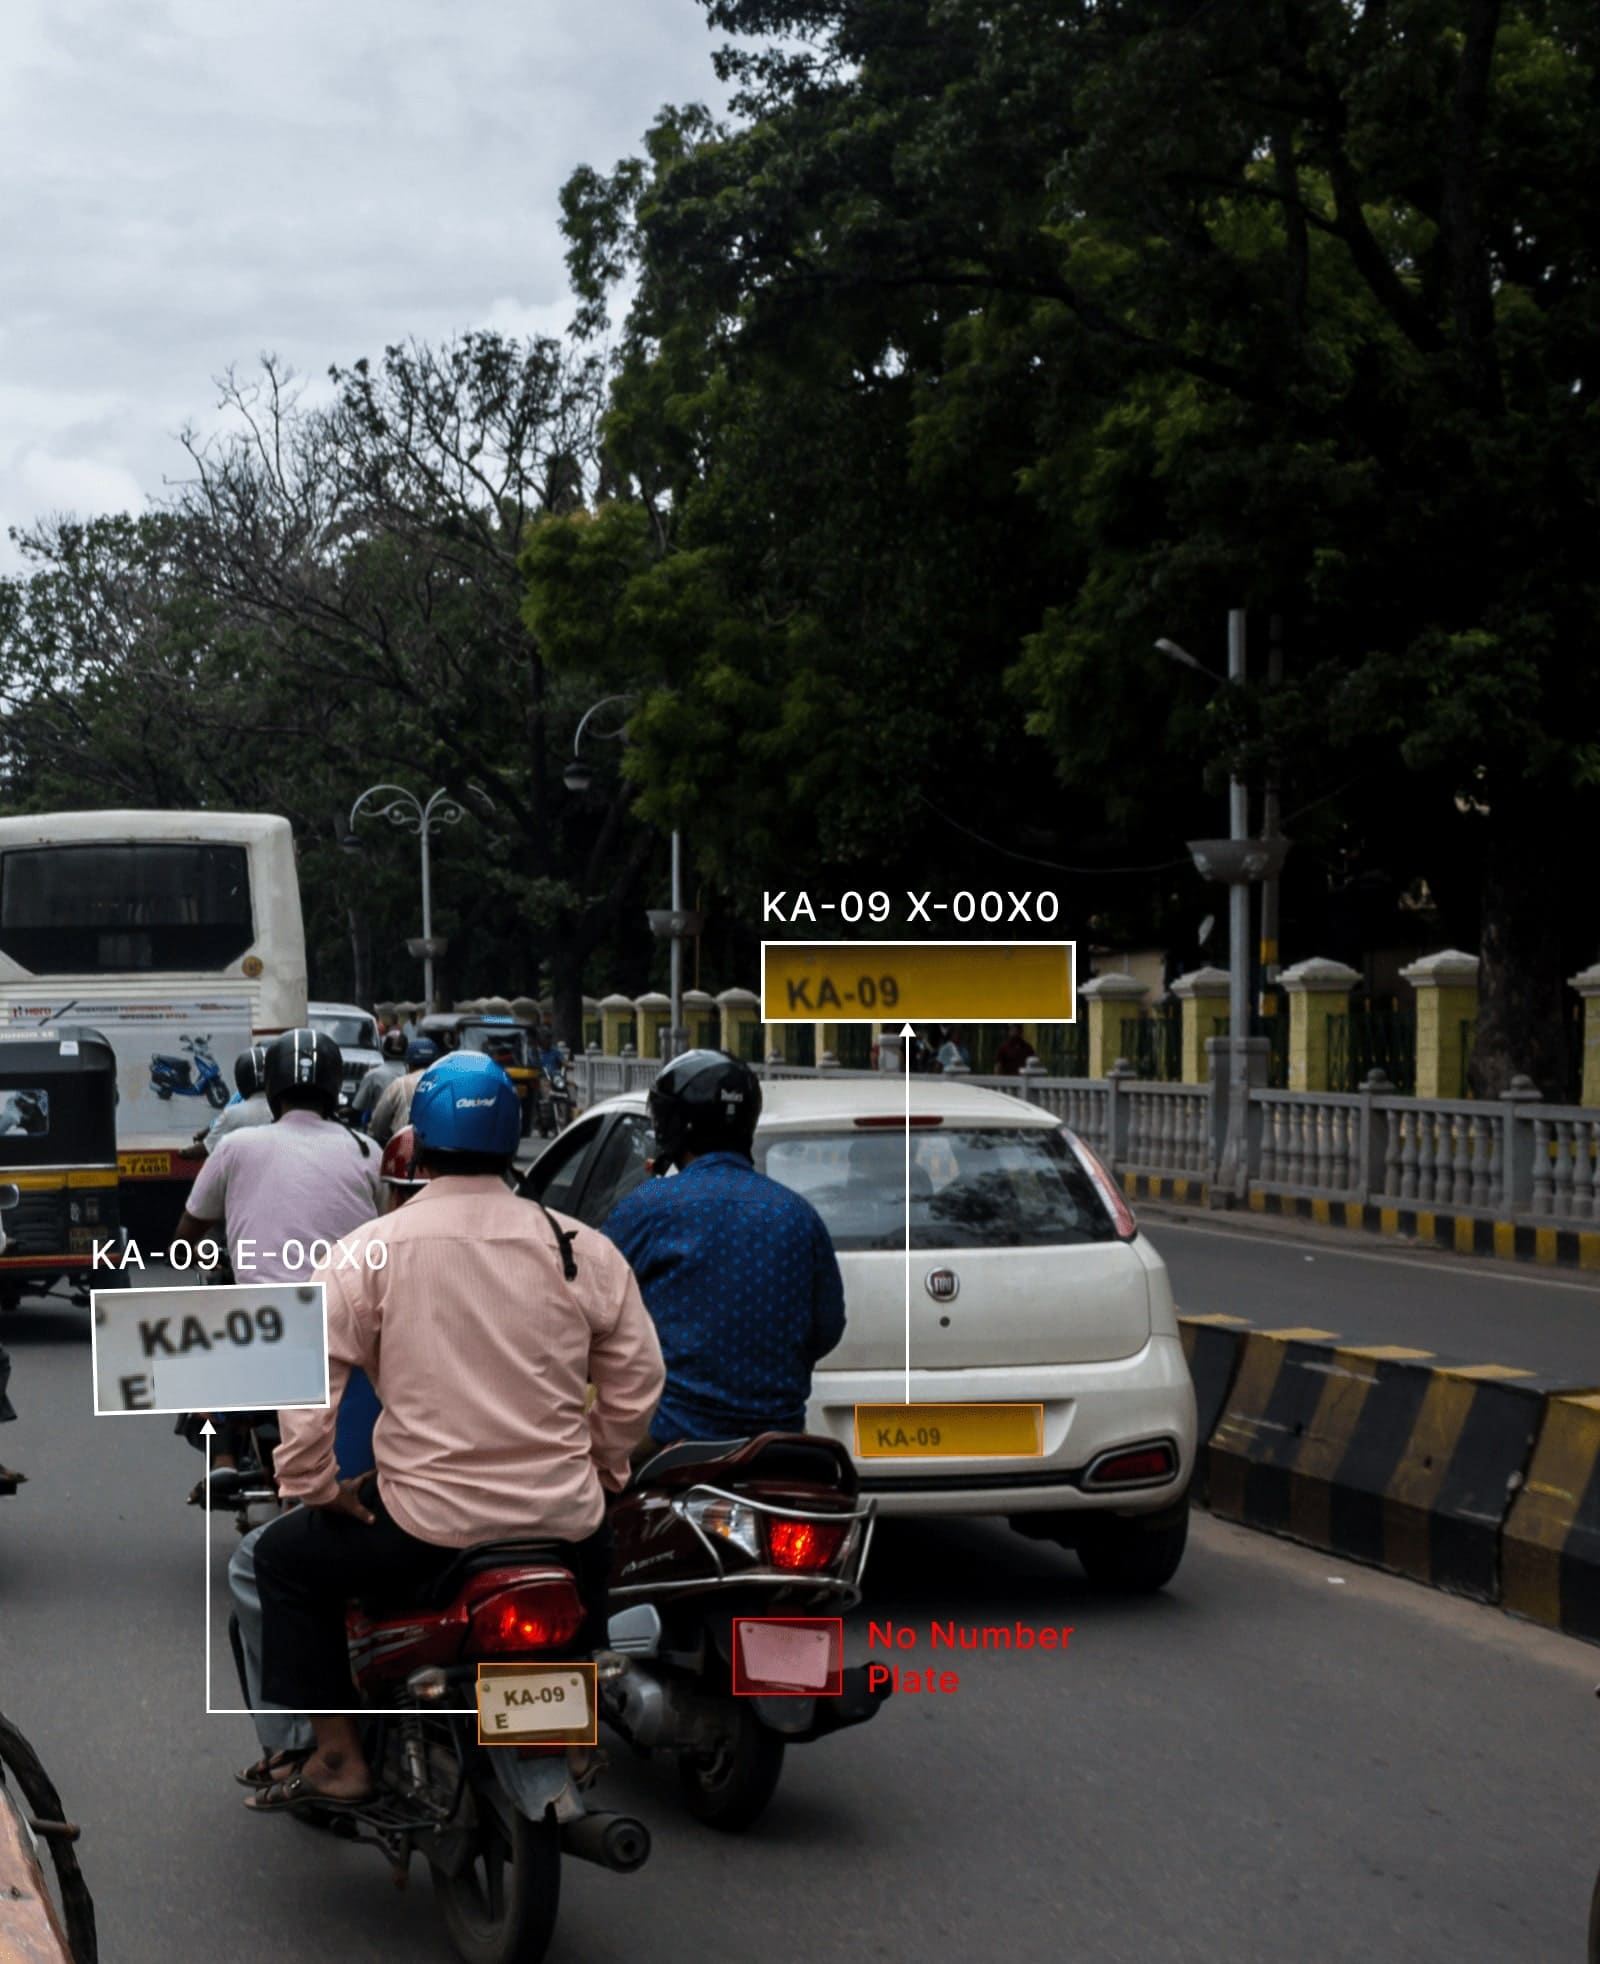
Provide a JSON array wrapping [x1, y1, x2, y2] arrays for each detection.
[[0, 811, 306, 1231]]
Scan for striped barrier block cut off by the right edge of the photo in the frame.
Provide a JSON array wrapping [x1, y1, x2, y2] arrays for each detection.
[[1502, 1391, 1600, 1642]]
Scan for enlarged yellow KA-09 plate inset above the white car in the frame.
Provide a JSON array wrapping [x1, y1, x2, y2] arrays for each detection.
[[762, 941, 1076, 1029]]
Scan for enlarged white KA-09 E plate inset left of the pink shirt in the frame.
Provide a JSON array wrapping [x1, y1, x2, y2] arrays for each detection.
[[90, 1282, 328, 1418]]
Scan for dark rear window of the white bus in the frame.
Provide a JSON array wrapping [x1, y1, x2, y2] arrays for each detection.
[[0, 845, 255, 976]]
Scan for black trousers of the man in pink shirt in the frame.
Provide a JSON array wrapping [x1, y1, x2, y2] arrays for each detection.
[[255, 1479, 611, 1713]]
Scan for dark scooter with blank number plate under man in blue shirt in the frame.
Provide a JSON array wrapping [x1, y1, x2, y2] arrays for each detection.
[[601, 1432, 887, 1832]]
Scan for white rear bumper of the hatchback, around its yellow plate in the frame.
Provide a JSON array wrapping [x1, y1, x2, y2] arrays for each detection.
[[809, 1336, 1196, 1514]]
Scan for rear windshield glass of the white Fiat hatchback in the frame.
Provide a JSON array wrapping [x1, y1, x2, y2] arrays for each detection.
[[756, 1125, 1117, 1253]]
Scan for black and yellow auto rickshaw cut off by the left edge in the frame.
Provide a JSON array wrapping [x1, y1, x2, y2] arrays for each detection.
[[0, 1025, 124, 1310]]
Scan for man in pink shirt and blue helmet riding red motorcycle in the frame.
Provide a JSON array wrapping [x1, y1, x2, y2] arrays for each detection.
[[251, 1053, 666, 1813]]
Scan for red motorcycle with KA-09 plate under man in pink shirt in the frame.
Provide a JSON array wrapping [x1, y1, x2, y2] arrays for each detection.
[[278, 1542, 650, 1964]]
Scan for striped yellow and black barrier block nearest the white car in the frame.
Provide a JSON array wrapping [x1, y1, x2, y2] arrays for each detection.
[[1207, 1330, 1551, 1603]]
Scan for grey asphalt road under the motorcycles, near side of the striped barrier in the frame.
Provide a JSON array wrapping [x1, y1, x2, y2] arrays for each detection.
[[0, 1288, 1600, 1964]]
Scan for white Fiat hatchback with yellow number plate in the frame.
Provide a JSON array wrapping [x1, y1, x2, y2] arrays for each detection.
[[522, 1076, 1196, 1589]]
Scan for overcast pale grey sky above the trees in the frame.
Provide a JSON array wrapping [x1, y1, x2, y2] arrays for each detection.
[[0, 0, 722, 568]]
